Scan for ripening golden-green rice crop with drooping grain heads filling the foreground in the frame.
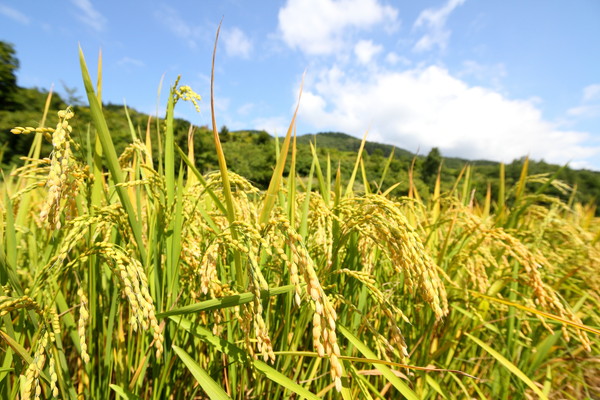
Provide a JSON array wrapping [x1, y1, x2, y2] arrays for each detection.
[[0, 45, 600, 400]]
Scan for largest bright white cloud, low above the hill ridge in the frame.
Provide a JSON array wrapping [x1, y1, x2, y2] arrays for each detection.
[[300, 66, 600, 163]]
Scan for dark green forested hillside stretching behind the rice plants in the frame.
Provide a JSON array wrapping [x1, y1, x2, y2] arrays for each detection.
[[0, 88, 600, 211]]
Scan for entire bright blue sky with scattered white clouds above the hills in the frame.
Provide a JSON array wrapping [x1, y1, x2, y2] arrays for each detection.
[[0, 0, 600, 170]]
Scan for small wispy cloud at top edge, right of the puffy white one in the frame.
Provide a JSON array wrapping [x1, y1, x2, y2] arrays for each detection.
[[413, 0, 465, 52]]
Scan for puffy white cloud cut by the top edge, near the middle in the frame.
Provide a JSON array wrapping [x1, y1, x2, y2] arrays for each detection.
[[279, 0, 398, 55]]
